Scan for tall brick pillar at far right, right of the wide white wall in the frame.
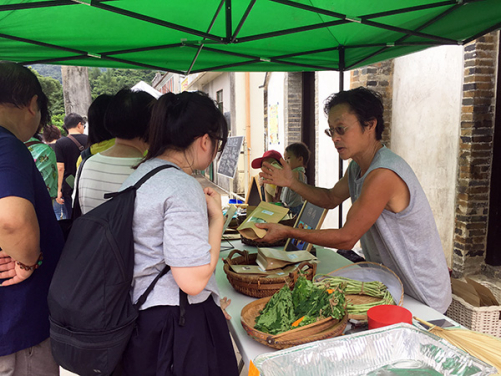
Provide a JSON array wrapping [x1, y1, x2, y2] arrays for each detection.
[[452, 32, 499, 277]]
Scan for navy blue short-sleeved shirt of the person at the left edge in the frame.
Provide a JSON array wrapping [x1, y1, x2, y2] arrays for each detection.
[[0, 125, 64, 356]]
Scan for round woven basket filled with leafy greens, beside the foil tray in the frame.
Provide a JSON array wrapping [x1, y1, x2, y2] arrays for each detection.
[[241, 276, 348, 349]]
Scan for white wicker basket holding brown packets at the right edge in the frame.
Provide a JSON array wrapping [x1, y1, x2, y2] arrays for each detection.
[[445, 294, 501, 337]]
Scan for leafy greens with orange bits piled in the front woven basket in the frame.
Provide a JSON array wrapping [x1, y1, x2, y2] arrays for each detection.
[[254, 276, 345, 335]]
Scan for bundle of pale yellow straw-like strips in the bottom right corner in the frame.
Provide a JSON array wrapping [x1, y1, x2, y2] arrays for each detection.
[[414, 316, 501, 375]]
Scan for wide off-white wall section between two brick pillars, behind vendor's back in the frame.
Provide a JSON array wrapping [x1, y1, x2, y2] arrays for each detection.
[[391, 46, 463, 265]]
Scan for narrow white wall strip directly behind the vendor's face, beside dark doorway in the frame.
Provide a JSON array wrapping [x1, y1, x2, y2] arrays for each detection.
[[316, 72, 351, 228]]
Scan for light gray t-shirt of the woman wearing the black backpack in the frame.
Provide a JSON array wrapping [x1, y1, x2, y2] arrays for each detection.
[[122, 159, 219, 310]]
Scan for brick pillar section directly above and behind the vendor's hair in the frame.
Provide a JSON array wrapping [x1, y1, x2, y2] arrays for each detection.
[[350, 60, 393, 148]]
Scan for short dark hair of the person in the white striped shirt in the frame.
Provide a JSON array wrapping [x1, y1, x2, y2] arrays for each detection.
[[104, 89, 156, 141]]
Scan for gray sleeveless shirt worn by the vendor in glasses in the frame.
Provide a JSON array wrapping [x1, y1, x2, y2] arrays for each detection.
[[348, 147, 452, 313]]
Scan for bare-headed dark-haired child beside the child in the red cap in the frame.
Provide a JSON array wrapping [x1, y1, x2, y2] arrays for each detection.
[[280, 142, 310, 215]]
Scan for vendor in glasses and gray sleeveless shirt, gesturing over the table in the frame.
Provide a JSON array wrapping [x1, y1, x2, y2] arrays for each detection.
[[256, 88, 452, 313]]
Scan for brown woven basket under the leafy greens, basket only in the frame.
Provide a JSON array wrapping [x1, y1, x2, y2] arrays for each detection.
[[240, 296, 348, 349]]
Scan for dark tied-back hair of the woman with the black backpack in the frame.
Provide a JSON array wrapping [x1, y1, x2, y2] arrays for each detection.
[[145, 91, 228, 160]]
